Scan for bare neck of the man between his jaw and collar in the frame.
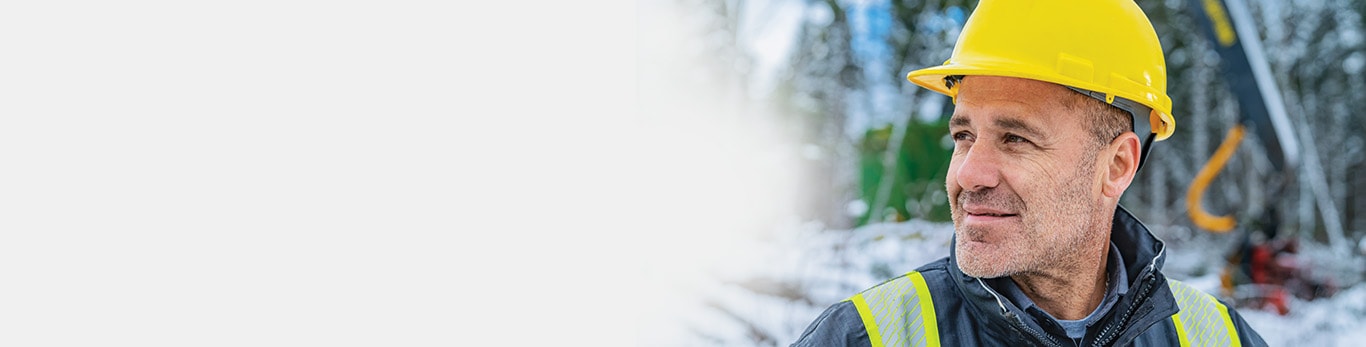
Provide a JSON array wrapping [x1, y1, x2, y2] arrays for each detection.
[[1011, 243, 1109, 321]]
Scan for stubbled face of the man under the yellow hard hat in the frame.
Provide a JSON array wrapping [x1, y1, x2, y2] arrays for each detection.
[[945, 77, 1108, 277]]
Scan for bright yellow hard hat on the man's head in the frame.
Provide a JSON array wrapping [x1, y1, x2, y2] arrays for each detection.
[[906, 0, 1176, 142]]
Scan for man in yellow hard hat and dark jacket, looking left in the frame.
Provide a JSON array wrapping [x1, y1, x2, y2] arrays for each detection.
[[794, 0, 1265, 346]]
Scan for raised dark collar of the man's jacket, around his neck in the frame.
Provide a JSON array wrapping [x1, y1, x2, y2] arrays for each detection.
[[947, 206, 1176, 346]]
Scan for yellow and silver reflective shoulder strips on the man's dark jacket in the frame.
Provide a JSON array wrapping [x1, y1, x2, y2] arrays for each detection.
[[846, 272, 1242, 347]]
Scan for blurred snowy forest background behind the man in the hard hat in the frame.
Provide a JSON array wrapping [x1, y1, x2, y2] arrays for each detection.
[[637, 0, 1366, 346]]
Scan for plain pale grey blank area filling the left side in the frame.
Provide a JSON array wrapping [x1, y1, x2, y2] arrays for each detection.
[[0, 0, 635, 346]]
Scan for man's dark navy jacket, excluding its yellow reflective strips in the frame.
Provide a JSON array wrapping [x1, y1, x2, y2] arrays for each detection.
[[792, 208, 1266, 346]]
